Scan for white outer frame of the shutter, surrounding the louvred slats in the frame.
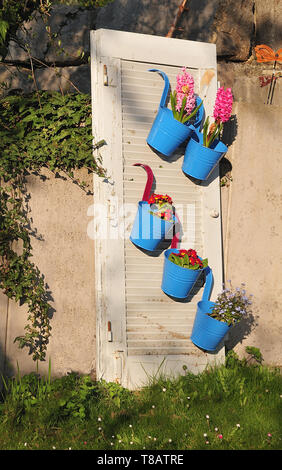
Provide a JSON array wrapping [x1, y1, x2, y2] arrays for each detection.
[[90, 29, 223, 386]]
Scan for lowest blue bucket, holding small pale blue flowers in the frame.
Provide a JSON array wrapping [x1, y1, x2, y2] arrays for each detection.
[[190, 300, 230, 351]]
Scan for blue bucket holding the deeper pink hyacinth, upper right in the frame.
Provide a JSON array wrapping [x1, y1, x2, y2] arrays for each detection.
[[182, 131, 228, 180]]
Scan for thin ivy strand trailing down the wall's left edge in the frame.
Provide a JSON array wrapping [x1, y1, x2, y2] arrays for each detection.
[[0, 179, 51, 359]]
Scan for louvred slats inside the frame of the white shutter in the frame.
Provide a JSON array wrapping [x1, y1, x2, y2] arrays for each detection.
[[121, 60, 203, 356]]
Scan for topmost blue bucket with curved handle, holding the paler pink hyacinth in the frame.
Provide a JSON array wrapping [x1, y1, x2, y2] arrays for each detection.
[[147, 69, 204, 157]]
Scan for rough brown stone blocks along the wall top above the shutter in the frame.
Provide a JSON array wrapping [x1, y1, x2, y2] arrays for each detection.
[[0, 0, 282, 105]]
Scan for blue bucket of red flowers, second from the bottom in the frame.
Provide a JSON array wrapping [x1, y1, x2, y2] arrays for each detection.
[[162, 248, 208, 299]]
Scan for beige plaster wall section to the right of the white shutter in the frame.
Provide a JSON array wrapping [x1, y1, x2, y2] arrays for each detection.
[[222, 103, 282, 365]]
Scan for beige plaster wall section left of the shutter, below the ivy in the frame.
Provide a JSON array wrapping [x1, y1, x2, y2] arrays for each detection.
[[0, 170, 96, 375]]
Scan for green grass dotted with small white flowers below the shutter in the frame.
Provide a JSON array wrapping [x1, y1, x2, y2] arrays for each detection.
[[0, 353, 282, 451]]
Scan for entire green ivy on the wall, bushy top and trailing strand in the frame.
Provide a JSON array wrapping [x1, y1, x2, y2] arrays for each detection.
[[0, 91, 105, 360]]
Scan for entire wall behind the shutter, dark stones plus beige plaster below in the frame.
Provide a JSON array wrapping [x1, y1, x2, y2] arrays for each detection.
[[0, 0, 282, 374]]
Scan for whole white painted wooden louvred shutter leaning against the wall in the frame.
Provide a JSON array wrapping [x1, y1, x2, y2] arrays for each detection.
[[91, 29, 223, 388]]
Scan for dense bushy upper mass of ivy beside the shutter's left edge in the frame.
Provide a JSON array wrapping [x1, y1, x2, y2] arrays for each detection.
[[0, 91, 104, 181]]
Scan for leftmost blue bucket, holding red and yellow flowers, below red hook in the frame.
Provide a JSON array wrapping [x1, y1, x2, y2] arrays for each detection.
[[129, 201, 174, 251]]
